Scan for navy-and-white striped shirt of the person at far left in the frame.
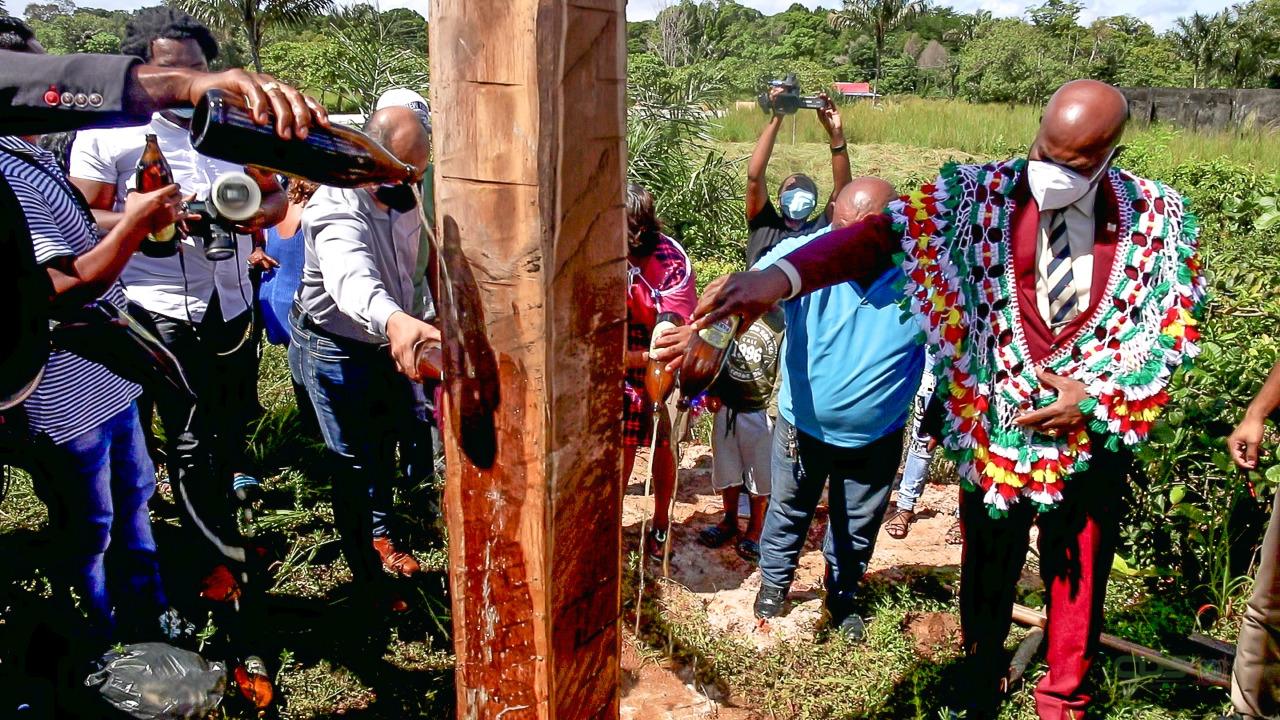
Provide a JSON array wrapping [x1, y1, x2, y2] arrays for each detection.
[[0, 137, 142, 443]]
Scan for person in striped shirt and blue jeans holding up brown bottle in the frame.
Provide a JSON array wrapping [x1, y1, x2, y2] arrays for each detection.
[[0, 17, 189, 640]]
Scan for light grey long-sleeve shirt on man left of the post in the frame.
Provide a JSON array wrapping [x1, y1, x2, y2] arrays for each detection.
[[296, 187, 422, 343]]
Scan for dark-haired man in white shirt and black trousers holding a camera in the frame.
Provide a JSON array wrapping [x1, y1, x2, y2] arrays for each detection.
[[70, 6, 287, 509]]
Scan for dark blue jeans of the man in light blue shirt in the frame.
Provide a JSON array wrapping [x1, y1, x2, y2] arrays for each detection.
[[760, 415, 902, 605]]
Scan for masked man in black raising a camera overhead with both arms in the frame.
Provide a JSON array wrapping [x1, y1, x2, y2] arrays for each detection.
[[746, 83, 852, 264]]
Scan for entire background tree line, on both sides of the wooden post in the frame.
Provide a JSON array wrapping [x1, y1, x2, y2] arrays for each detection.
[[15, 0, 1280, 110]]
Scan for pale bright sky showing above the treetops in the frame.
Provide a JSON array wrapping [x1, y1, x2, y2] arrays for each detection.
[[22, 0, 1231, 31]]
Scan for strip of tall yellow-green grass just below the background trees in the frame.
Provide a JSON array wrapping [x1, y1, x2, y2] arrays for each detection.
[[716, 97, 1280, 173]]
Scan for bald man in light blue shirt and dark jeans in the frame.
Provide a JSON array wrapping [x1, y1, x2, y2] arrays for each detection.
[[754, 177, 924, 639]]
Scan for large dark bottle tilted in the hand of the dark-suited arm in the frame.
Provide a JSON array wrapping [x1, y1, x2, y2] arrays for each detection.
[[191, 90, 419, 187]]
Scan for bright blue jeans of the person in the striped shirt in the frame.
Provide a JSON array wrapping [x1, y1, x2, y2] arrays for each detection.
[[32, 404, 168, 639]]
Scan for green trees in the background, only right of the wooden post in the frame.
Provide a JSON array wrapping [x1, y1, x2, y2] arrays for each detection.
[[627, 0, 1280, 102]]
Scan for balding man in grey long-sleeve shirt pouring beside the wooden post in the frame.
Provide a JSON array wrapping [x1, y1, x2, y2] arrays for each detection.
[[289, 106, 440, 606]]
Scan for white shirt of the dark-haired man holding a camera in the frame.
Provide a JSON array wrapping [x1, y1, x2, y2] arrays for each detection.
[[70, 113, 253, 323]]
